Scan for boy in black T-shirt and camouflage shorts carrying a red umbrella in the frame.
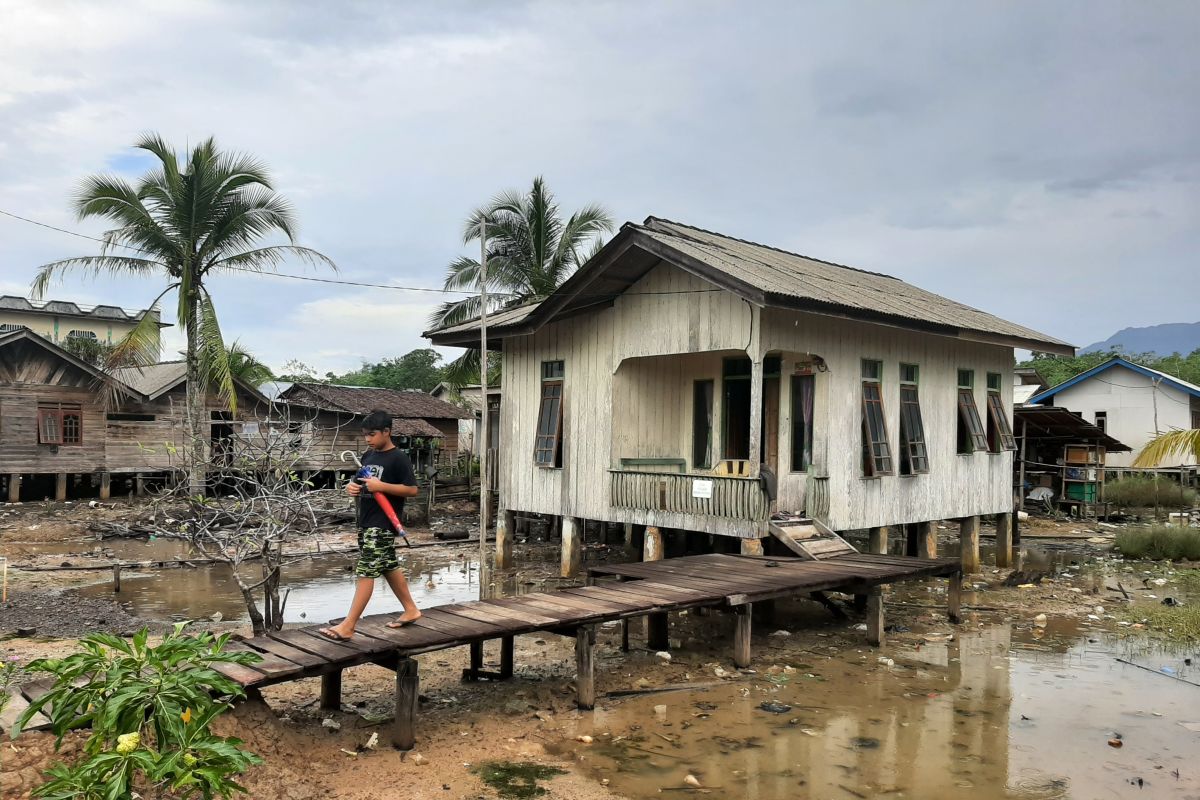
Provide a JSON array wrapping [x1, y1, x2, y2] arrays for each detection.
[[320, 410, 421, 642]]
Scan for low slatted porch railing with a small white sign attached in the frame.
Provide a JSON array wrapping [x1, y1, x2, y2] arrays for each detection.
[[608, 469, 770, 522]]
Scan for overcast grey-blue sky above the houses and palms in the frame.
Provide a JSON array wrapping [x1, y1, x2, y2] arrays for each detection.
[[0, 0, 1200, 371]]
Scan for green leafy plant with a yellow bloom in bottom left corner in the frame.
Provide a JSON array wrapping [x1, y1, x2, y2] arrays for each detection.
[[13, 622, 262, 800]]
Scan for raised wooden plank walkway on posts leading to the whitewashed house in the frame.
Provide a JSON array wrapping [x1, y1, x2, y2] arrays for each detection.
[[5, 553, 961, 750]]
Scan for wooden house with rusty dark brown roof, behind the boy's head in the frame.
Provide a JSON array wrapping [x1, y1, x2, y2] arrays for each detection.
[[277, 383, 470, 469]]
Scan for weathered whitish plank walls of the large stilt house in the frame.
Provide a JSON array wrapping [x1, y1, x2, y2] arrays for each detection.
[[500, 264, 1013, 536]]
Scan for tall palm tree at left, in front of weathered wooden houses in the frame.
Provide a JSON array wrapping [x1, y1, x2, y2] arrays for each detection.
[[32, 133, 337, 492]]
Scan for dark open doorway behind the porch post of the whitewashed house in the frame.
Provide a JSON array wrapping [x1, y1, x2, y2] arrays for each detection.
[[721, 355, 780, 475]]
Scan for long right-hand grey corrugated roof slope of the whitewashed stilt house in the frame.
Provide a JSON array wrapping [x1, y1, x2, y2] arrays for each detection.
[[632, 217, 1070, 347]]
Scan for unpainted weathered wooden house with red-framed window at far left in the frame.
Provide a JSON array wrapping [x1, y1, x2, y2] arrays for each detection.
[[0, 329, 307, 501]]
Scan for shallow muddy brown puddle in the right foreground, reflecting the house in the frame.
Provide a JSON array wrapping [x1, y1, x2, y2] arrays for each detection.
[[564, 625, 1200, 800]]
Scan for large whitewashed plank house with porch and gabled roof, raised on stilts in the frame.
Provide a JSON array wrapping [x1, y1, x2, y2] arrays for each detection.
[[426, 217, 1074, 571]]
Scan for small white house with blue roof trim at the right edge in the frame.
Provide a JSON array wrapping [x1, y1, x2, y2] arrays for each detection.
[[1030, 356, 1200, 468]]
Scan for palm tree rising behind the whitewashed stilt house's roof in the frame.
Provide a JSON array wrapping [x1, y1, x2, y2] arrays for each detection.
[[430, 176, 613, 386]]
